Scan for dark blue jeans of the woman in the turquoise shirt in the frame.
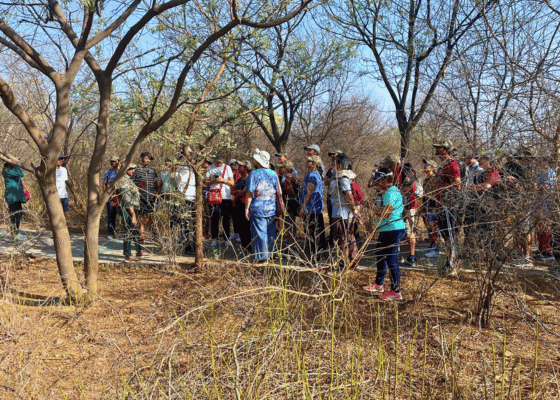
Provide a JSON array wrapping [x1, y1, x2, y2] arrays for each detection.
[[375, 229, 406, 293]]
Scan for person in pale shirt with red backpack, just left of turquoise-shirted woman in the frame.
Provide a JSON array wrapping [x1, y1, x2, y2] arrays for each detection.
[[328, 152, 359, 269]]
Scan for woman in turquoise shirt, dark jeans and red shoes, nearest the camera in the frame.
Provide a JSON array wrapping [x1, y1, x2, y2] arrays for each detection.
[[364, 168, 406, 301]]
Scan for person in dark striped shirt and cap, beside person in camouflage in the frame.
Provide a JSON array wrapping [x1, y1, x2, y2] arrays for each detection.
[[132, 151, 161, 253]]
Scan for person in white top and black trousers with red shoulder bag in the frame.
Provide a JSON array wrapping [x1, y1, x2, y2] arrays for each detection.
[[206, 157, 235, 247]]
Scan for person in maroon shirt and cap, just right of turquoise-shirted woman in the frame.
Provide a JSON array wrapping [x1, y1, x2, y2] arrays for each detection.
[[425, 140, 461, 273]]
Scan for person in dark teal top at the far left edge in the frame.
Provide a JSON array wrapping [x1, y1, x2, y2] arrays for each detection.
[[2, 162, 27, 241]]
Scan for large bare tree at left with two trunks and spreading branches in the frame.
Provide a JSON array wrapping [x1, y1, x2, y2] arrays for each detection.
[[0, 0, 311, 301]]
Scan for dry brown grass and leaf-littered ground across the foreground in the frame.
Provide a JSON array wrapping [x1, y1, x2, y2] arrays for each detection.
[[0, 255, 560, 399]]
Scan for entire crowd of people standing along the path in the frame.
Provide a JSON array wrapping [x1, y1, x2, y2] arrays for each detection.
[[3, 140, 560, 300]]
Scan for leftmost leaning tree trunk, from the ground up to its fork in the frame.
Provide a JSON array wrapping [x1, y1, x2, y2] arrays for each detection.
[[38, 174, 85, 303]]
